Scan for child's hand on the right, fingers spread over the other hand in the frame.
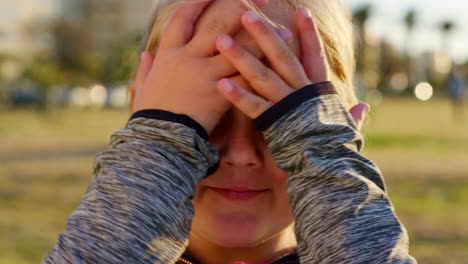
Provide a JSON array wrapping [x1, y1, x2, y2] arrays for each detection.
[[217, 8, 329, 119]]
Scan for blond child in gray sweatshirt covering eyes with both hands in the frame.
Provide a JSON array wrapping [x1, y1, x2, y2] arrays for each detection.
[[44, 0, 415, 264]]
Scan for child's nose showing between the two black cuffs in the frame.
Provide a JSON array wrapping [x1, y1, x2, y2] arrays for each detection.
[[210, 108, 266, 168]]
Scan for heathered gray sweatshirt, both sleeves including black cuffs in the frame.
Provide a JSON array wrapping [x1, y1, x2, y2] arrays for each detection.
[[42, 82, 416, 264]]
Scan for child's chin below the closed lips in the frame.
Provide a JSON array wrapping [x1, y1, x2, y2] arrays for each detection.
[[191, 184, 294, 249]]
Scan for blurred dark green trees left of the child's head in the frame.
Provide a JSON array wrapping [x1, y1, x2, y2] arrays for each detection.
[[18, 15, 141, 106]]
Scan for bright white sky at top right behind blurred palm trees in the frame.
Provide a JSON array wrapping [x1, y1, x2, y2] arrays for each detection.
[[340, 0, 468, 63]]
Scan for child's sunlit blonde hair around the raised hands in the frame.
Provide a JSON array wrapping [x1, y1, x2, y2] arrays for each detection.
[[137, 0, 358, 108]]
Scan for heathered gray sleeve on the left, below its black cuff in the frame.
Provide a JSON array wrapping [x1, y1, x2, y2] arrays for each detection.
[[43, 118, 219, 264]]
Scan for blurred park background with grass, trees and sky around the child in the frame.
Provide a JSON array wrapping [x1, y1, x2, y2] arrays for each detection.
[[0, 0, 468, 264]]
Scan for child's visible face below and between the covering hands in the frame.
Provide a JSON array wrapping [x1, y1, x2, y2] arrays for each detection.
[[190, 0, 298, 248]]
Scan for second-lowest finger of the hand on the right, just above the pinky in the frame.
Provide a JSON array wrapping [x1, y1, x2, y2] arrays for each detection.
[[216, 35, 294, 103]]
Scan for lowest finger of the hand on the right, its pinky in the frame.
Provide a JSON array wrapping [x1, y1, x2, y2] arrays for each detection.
[[218, 79, 272, 119]]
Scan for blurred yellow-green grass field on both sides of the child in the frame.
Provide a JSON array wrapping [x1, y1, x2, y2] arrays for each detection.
[[0, 98, 468, 264]]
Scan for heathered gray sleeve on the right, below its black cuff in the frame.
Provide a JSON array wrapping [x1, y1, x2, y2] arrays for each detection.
[[263, 94, 416, 264]]
